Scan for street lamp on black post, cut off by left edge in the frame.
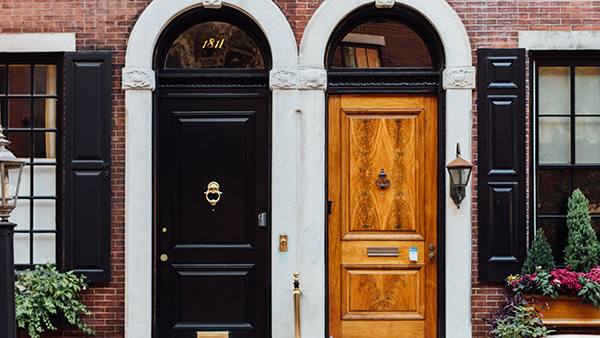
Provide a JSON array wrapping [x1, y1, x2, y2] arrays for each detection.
[[0, 126, 25, 338]]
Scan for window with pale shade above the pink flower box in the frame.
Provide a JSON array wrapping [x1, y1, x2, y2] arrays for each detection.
[[533, 54, 600, 264]]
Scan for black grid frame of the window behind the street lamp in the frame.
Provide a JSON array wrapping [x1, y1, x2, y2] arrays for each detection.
[[0, 52, 64, 271]]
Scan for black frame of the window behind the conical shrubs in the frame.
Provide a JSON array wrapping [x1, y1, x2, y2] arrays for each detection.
[[529, 50, 600, 267]]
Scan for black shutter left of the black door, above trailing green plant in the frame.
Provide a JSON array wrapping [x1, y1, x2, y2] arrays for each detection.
[[64, 53, 111, 282]]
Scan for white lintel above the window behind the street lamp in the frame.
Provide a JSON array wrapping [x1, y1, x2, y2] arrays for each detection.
[[0, 33, 76, 53]]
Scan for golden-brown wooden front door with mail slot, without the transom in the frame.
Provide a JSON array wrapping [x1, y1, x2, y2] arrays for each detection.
[[327, 95, 438, 338]]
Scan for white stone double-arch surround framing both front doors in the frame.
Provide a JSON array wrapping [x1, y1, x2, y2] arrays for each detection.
[[123, 0, 474, 338]]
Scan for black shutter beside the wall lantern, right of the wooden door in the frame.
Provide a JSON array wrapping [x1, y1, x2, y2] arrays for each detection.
[[477, 49, 527, 282]]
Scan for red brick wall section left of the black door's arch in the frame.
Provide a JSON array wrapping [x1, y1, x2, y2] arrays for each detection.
[[0, 0, 150, 337]]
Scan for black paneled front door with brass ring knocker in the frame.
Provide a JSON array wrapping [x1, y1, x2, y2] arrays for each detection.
[[155, 96, 270, 338]]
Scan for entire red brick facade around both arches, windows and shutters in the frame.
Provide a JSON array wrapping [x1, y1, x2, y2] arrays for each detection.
[[0, 0, 600, 337]]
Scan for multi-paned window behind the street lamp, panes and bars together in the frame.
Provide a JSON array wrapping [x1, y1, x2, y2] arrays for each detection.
[[0, 55, 62, 268]]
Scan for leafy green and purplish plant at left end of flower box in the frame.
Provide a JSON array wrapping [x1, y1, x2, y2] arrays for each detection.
[[487, 292, 554, 338]]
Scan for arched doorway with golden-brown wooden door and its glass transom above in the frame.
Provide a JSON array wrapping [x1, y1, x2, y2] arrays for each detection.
[[326, 5, 445, 337]]
